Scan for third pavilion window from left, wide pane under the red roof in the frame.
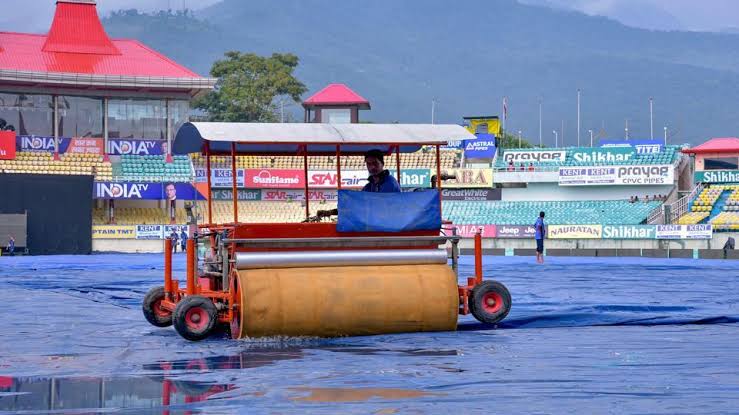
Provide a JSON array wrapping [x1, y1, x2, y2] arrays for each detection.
[[108, 99, 168, 140]]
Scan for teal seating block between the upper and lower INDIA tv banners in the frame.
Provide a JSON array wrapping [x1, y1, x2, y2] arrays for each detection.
[[113, 155, 193, 183]]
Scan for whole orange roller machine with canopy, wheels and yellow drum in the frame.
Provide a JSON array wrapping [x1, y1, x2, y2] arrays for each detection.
[[143, 123, 511, 340]]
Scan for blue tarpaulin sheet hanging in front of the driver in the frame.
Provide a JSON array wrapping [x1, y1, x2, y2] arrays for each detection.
[[336, 190, 441, 232]]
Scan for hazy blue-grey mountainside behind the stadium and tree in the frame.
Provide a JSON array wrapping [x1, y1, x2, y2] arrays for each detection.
[[105, 0, 739, 145]]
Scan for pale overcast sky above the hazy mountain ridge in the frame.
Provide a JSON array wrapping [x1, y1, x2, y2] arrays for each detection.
[[0, 0, 739, 33]]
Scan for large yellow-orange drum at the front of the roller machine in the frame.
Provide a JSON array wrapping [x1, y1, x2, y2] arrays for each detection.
[[238, 264, 459, 337]]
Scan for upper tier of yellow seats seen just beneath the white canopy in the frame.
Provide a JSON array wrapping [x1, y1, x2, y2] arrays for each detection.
[[188, 147, 461, 170]]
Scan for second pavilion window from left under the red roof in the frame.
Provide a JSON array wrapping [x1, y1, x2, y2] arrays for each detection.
[[57, 96, 103, 138]]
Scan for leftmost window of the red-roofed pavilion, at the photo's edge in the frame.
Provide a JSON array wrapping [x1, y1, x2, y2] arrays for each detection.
[[0, 93, 54, 136]]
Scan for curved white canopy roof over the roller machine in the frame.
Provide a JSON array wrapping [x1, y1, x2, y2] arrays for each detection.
[[173, 122, 475, 154]]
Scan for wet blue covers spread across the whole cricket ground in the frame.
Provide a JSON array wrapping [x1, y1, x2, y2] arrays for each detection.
[[0, 255, 739, 414]]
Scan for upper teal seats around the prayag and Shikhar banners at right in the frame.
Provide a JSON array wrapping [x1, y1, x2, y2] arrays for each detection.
[[495, 146, 680, 170]]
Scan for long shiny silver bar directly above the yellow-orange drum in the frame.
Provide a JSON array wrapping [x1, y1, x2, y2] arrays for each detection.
[[236, 249, 447, 270]]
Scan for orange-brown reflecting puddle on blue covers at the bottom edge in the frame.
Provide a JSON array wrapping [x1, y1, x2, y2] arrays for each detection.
[[289, 387, 439, 402]]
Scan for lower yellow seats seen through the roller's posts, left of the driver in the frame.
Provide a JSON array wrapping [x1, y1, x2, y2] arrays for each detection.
[[198, 201, 336, 223]]
